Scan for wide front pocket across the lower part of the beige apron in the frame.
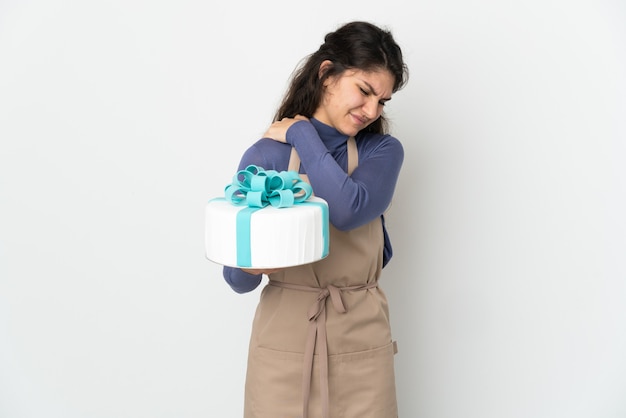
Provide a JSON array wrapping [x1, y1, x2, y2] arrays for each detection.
[[244, 342, 397, 418]]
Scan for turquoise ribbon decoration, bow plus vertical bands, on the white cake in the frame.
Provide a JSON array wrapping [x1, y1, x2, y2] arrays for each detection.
[[224, 165, 316, 267]]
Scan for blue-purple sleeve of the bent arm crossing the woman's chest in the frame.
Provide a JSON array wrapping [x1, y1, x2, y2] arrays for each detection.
[[286, 121, 404, 230]]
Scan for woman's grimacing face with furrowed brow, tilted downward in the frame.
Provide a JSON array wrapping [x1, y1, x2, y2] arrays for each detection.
[[313, 65, 394, 136]]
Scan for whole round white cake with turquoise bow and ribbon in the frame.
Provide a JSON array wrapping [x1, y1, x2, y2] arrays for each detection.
[[205, 166, 329, 269]]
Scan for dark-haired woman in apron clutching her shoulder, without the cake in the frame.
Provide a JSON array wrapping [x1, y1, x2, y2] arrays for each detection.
[[224, 22, 408, 418]]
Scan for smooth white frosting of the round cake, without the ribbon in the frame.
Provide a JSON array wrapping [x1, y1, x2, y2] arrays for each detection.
[[205, 197, 328, 268]]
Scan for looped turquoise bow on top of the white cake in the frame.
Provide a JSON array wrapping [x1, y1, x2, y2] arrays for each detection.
[[224, 165, 313, 208]]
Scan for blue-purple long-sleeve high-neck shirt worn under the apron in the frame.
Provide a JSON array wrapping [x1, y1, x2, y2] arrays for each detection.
[[224, 119, 404, 293]]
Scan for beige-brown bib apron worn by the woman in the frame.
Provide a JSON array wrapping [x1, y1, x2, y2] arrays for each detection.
[[244, 138, 398, 418]]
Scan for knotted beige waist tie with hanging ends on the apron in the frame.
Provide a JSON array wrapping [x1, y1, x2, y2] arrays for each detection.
[[268, 280, 378, 418]]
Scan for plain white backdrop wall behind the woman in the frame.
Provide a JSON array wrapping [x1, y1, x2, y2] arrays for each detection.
[[0, 0, 626, 418]]
